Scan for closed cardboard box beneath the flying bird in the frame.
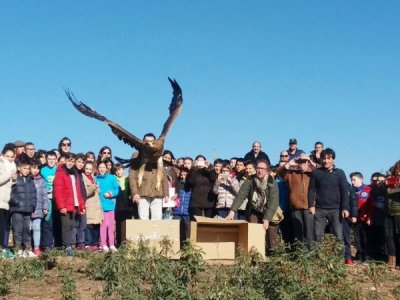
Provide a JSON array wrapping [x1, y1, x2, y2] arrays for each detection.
[[121, 220, 180, 258]]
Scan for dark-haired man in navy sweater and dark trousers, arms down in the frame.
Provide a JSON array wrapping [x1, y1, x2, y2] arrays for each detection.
[[308, 148, 349, 241]]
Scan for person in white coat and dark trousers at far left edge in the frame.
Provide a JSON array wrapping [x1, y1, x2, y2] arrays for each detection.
[[0, 145, 17, 258]]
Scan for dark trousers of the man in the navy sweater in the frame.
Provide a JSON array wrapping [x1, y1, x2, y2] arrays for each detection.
[[314, 207, 343, 242]]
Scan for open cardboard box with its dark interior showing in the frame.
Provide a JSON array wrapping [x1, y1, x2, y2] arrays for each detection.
[[190, 217, 265, 260]]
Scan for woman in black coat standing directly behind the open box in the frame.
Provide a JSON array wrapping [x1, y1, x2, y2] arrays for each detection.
[[187, 155, 215, 220]]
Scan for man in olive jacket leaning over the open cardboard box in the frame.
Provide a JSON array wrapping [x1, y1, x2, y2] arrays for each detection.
[[226, 160, 279, 237]]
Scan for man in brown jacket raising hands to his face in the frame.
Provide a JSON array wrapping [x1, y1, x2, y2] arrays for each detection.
[[278, 153, 314, 249]]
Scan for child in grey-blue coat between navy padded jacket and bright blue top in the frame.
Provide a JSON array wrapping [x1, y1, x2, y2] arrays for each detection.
[[31, 161, 49, 256]]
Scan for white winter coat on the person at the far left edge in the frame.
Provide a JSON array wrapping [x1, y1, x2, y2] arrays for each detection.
[[0, 157, 17, 210]]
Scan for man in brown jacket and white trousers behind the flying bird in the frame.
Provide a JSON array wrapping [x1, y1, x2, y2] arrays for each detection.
[[129, 133, 168, 220]]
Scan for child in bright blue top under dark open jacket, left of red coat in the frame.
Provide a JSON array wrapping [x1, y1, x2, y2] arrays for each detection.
[[40, 150, 61, 250]]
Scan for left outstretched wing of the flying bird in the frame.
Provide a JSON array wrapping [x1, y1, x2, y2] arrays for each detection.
[[65, 89, 143, 150]]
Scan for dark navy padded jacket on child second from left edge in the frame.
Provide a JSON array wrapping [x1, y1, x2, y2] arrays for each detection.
[[10, 175, 37, 213]]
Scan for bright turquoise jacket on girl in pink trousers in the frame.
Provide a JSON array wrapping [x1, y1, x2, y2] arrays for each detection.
[[96, 173, 120, 212]]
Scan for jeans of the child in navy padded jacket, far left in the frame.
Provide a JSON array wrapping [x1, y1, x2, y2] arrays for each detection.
[[11, 213, 32, 249]]
